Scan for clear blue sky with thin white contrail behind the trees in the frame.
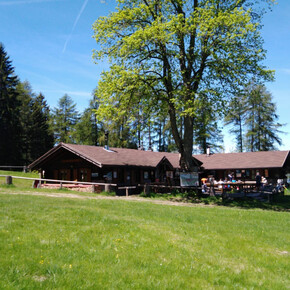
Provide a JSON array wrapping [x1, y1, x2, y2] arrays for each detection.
[[0, 0, 290, 151]]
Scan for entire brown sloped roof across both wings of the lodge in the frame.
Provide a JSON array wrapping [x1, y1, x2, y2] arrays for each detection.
[[29, 143, 290, 170]]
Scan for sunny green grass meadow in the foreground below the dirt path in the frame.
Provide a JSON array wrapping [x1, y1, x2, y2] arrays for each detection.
[[0, 189, 290, 289]]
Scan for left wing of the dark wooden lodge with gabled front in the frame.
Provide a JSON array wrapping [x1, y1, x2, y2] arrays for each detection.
[[29, 143, 201, 186]]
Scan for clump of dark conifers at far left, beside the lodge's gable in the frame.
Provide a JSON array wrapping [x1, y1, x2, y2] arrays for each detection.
[[0, 43, 54, 166]]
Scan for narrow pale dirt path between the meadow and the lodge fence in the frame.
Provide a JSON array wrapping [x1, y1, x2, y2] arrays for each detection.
[[0, 191, 214, 207]]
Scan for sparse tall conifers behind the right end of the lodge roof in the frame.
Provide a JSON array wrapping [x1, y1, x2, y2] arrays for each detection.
[[225, 82, 283, 152]]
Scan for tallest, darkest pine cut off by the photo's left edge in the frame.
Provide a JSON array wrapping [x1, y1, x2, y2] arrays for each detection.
[[0, 43, 22, 165]]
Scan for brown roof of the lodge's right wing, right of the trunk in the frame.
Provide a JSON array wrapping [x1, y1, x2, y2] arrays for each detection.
[[194, 151, 289, 170]]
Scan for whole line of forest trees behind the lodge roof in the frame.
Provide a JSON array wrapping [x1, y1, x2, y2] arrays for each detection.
[[0, 43, 283, 165]]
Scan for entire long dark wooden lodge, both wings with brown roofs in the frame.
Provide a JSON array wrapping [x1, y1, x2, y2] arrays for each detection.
[[29, 143, 290, 186]]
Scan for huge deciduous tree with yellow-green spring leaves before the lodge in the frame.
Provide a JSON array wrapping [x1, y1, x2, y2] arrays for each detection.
[[93, 0, 272, 171]]
